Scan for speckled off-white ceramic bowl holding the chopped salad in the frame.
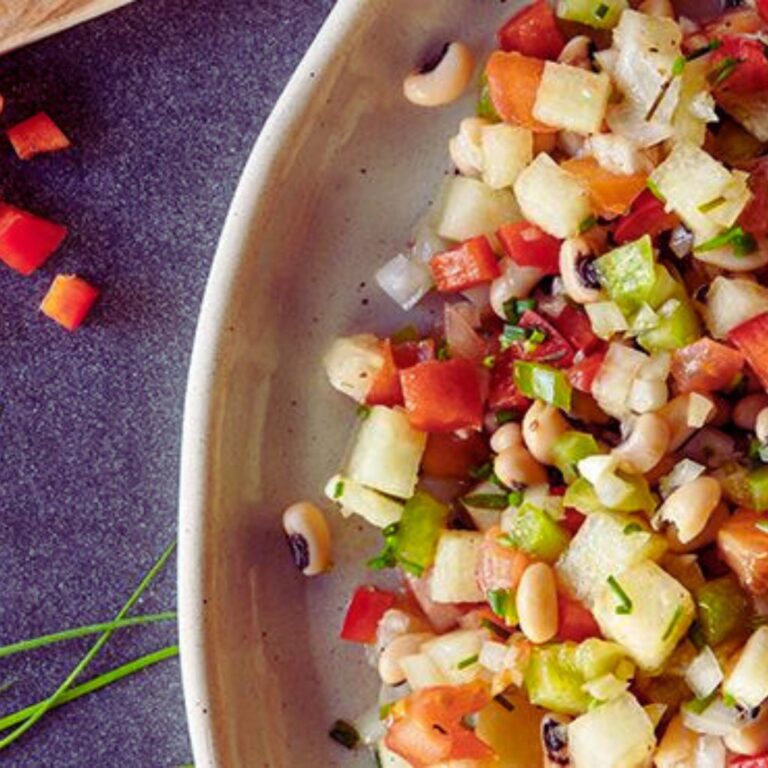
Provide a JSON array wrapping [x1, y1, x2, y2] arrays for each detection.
[[179, 0, 516, 768]]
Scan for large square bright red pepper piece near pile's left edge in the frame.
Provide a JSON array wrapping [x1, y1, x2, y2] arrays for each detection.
[[400, 359, 483, 432]]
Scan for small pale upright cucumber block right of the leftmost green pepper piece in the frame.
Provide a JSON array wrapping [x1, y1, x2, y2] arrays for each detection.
[[432, 531, 484, 603]]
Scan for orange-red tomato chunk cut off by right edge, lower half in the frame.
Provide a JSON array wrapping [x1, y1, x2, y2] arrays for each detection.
[[717, 509, 768, 595]]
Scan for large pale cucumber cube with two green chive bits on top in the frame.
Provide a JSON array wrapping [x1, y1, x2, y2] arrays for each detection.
[[593, 560, 695, 672]]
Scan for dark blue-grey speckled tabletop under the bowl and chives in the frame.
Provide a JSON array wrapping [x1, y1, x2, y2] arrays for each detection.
[[0, 0, 333, 768]]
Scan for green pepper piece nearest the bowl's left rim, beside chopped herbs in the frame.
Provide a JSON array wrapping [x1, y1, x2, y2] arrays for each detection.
[[394, 491, 448, 576]]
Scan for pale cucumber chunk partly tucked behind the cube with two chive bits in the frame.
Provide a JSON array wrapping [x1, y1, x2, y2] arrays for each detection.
[[556, 512, 667, 606]]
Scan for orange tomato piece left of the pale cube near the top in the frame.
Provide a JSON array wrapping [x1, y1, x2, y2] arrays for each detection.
[[485, 51, 557, 133]]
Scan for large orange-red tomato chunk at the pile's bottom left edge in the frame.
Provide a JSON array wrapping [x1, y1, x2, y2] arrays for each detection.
[[384, 682, 495, 768]]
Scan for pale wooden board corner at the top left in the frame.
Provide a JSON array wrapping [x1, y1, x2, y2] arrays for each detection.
[[0, 0, 132, 54]]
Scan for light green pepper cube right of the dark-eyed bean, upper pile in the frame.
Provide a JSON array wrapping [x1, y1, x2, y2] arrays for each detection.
[[595, 235, 656, 314]]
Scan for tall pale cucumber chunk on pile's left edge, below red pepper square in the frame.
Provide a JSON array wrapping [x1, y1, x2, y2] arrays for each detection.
[[345, 405, 427, 499]]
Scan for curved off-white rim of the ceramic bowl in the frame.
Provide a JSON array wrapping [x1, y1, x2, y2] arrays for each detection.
[[177, 0, 373, 768]]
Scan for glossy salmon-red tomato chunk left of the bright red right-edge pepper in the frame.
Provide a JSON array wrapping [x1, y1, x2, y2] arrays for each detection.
[[672, 336, 744, 392]]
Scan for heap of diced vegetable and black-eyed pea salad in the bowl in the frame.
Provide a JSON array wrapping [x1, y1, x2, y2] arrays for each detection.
[[294, 0, 768, 768]]
